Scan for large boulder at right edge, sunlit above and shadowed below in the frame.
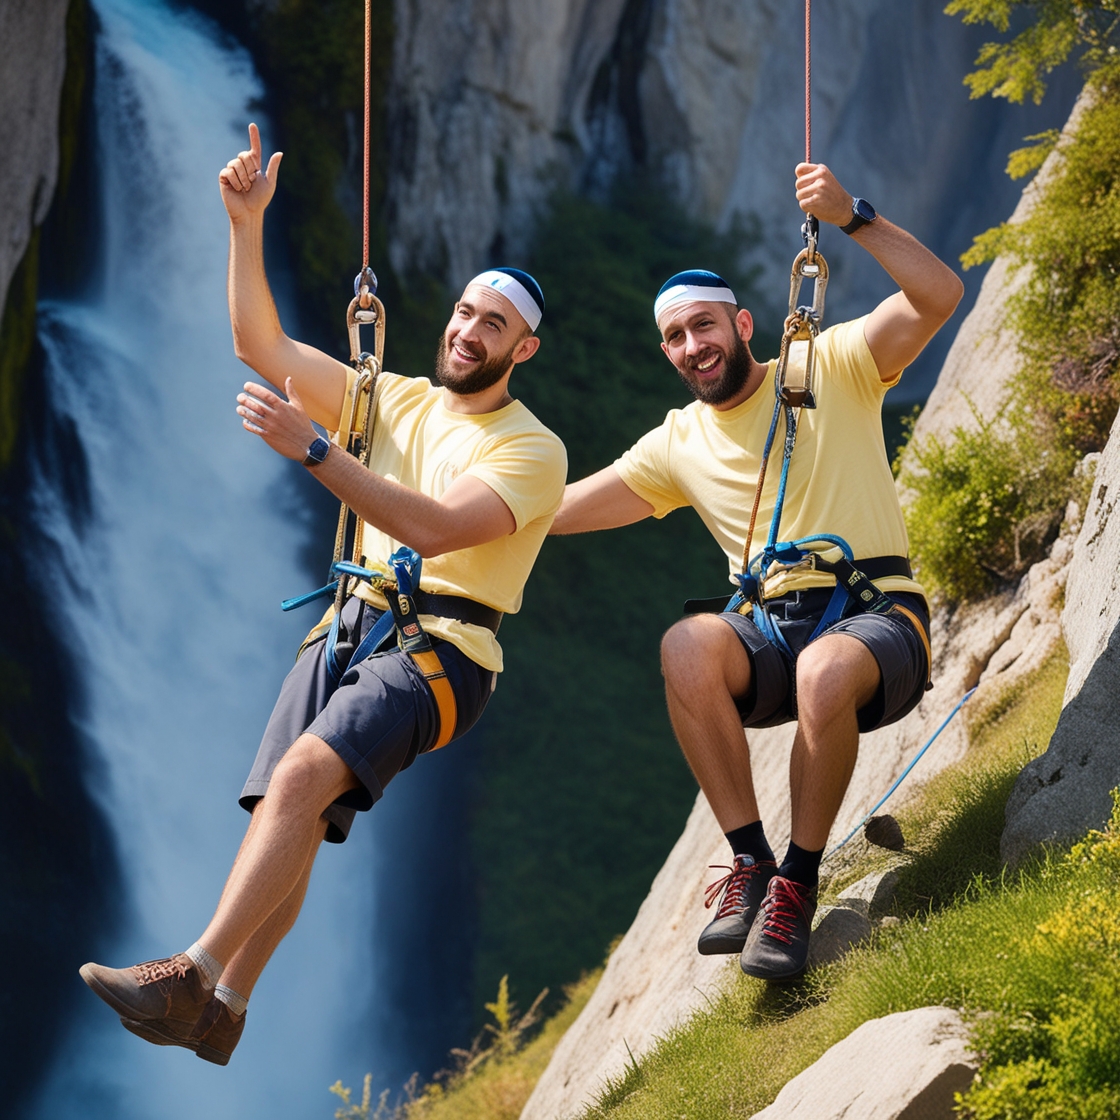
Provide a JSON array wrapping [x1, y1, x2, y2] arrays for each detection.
[[1000, 420, 1120, 866]]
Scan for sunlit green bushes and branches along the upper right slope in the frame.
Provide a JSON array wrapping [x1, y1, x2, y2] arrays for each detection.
[[922, 0, 1120, 598]]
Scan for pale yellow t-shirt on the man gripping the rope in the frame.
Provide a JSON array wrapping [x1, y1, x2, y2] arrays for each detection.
[[615, 319, 924, 597]]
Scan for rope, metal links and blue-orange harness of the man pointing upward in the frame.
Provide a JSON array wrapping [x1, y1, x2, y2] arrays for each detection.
[[280, 0, 481, 750]]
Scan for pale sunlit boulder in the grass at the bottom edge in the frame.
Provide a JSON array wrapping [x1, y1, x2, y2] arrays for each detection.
[[753, 1007, 977, 1120]]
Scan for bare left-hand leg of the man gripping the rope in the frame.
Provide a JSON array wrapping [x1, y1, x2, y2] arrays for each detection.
[[661, 615, 758, 832]]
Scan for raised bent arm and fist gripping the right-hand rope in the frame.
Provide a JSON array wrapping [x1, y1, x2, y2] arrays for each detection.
[[796, 164, 964, 381]]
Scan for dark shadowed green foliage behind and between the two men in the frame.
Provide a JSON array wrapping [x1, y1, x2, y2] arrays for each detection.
[[463, 185, 773, 1005]]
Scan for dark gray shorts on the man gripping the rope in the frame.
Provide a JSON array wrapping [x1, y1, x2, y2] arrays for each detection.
[[719, 588, 930, 731]]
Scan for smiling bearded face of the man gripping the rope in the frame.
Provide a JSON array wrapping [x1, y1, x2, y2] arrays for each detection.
[[659, 300, 754, 407]]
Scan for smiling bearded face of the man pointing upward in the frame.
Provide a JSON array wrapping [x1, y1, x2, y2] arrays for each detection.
[[436, 284, 540, 396]]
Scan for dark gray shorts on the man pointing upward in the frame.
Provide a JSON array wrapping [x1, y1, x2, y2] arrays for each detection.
[[240, 598, 497, 843]]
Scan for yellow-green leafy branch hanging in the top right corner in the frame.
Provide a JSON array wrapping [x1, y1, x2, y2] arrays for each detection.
[[945, 0, 1120, 104]]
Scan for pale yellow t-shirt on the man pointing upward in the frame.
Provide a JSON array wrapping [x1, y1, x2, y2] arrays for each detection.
[[329, 373, 568, 672]]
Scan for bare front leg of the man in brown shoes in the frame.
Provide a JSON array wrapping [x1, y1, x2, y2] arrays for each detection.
[[198, 735, 358, 963]]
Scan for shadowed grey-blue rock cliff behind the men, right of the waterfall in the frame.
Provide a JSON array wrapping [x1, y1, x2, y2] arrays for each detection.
[[388, 0, 1076, 395]]
